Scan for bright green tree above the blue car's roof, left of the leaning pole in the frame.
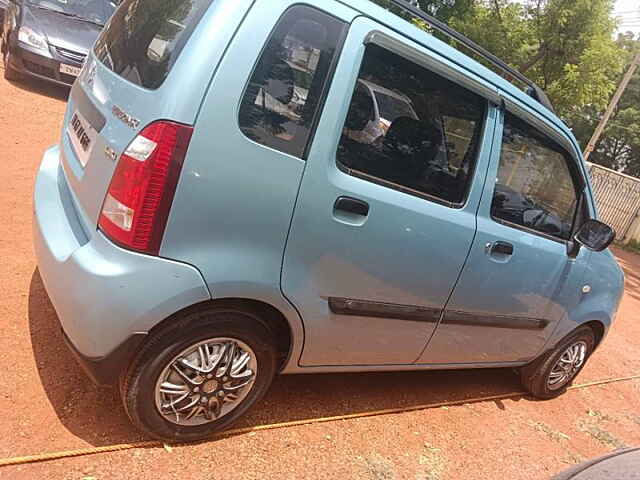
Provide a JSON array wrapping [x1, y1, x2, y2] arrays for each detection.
[[451, 0, 624, 118]]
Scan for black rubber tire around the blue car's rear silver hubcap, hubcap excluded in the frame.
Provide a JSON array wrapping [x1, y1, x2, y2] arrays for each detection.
[[120, 308, 277, 442]]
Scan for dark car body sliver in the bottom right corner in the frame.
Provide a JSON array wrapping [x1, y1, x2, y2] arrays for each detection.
[[553, 448, 640, 480]]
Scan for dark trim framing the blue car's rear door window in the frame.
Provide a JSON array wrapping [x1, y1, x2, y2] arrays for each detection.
[[336, 30, 492, 210]]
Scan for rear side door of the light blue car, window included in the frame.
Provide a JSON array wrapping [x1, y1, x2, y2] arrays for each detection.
[[282, 17, 497, 366]]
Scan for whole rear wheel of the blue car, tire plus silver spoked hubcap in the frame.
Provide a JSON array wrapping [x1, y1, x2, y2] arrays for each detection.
[[121, 308, 277, 442]]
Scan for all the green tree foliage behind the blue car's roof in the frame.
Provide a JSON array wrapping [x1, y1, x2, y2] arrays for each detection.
[[375, 0, 640, 175]]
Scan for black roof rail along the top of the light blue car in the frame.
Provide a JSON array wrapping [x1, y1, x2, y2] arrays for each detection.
[[380, 0, 554, 112]]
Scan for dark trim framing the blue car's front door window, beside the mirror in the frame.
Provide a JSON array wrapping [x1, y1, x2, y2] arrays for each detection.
[[489, 108, 591, 245]]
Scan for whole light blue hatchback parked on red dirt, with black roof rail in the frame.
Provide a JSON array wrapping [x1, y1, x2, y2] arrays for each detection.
[[33, 0, 623, 440]]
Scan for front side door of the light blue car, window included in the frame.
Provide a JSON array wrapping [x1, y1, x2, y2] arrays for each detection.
[[418, 107, 590, 364]]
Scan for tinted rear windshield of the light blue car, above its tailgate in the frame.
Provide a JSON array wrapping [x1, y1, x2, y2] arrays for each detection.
[[94, 0, 214, 89]]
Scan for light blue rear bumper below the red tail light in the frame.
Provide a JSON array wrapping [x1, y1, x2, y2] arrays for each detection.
[[33, 147, 211, 383]]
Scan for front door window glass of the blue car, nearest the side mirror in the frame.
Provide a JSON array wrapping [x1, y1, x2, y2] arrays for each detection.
[[491, 113, 577, 240]]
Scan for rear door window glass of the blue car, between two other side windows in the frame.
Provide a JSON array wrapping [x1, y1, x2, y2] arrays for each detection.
[[338, 45, 487, 206]]
